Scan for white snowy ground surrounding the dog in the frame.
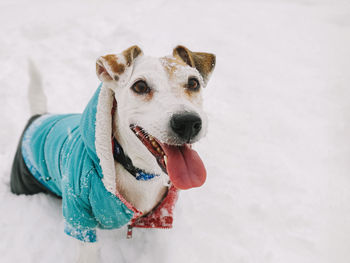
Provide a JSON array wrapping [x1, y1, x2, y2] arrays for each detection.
[[0, 0, 350, 263]]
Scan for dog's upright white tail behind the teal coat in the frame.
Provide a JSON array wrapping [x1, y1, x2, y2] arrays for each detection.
[[28, 59, 47, 115]]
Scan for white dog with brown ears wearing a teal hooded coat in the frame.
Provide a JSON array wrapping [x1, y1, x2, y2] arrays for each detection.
[[11, 46, 215, 262]]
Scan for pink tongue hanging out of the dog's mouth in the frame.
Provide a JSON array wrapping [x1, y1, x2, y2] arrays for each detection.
[[162, 144, 207, 190]]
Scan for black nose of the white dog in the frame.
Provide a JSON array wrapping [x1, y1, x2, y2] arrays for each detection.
[[170, 113, 202, 142]]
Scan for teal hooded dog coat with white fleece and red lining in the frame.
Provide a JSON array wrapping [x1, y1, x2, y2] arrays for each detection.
[[21, 85, 178, 242]]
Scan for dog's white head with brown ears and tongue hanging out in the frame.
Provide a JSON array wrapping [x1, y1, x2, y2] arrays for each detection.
[[96, 46, 215, 189]]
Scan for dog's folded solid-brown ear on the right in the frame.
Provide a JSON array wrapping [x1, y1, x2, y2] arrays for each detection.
[[173, 46, 215, 82]]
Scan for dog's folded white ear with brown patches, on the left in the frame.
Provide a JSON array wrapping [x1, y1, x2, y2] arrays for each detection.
[[96, 46, 142, 82]]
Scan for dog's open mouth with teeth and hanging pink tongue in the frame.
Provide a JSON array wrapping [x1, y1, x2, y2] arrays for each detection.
[[130, 124, 206, 189]]
